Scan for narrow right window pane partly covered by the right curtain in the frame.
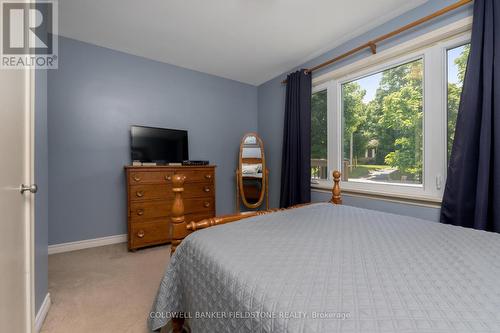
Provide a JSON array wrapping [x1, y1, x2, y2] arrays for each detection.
[[447, 44, 470, 159]]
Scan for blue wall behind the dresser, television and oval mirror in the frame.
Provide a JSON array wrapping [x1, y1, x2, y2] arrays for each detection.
[[48, 37, 258, 244]]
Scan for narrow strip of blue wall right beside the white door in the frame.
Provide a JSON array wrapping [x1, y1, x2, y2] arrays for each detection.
[[35, 70, 49, 312]]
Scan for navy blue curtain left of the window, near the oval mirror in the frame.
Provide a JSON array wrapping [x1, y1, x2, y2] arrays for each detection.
[[280, 70, 311, 207]]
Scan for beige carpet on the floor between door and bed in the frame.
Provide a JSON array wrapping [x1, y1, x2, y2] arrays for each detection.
[[42, 244, 170, 333]]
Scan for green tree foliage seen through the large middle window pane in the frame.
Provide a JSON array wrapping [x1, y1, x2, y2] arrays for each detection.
[[342, 60, 423, 180]]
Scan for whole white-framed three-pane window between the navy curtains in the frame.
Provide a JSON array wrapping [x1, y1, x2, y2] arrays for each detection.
[[311, 33, 470, 201]]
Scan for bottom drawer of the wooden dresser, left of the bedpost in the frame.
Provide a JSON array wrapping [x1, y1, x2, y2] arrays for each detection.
[[129, 220, 171, 248]]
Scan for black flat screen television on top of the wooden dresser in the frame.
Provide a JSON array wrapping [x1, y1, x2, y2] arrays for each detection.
[[130, 126, 189, 164]]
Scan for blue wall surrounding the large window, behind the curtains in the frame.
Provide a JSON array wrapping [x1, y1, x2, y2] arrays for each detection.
[[258, 0, 472, 220]]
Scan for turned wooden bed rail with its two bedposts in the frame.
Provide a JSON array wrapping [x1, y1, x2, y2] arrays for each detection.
[[171, 171, 342, 254]]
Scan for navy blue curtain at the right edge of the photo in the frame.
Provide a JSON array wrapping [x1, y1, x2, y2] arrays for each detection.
[[441, 0, 500, 232]]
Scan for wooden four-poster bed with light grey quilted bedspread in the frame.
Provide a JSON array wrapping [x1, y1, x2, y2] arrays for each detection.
[[148, 173, 500, 333]]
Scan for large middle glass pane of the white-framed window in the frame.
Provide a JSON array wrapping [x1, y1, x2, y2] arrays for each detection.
[[341, 59, 423, 184]]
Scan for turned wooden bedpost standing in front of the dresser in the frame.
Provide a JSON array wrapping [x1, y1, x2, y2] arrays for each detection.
[[170, 175, 189, 254]]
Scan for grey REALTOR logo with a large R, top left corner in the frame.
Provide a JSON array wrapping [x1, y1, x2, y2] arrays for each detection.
[[0, 0, 58, 69]]
